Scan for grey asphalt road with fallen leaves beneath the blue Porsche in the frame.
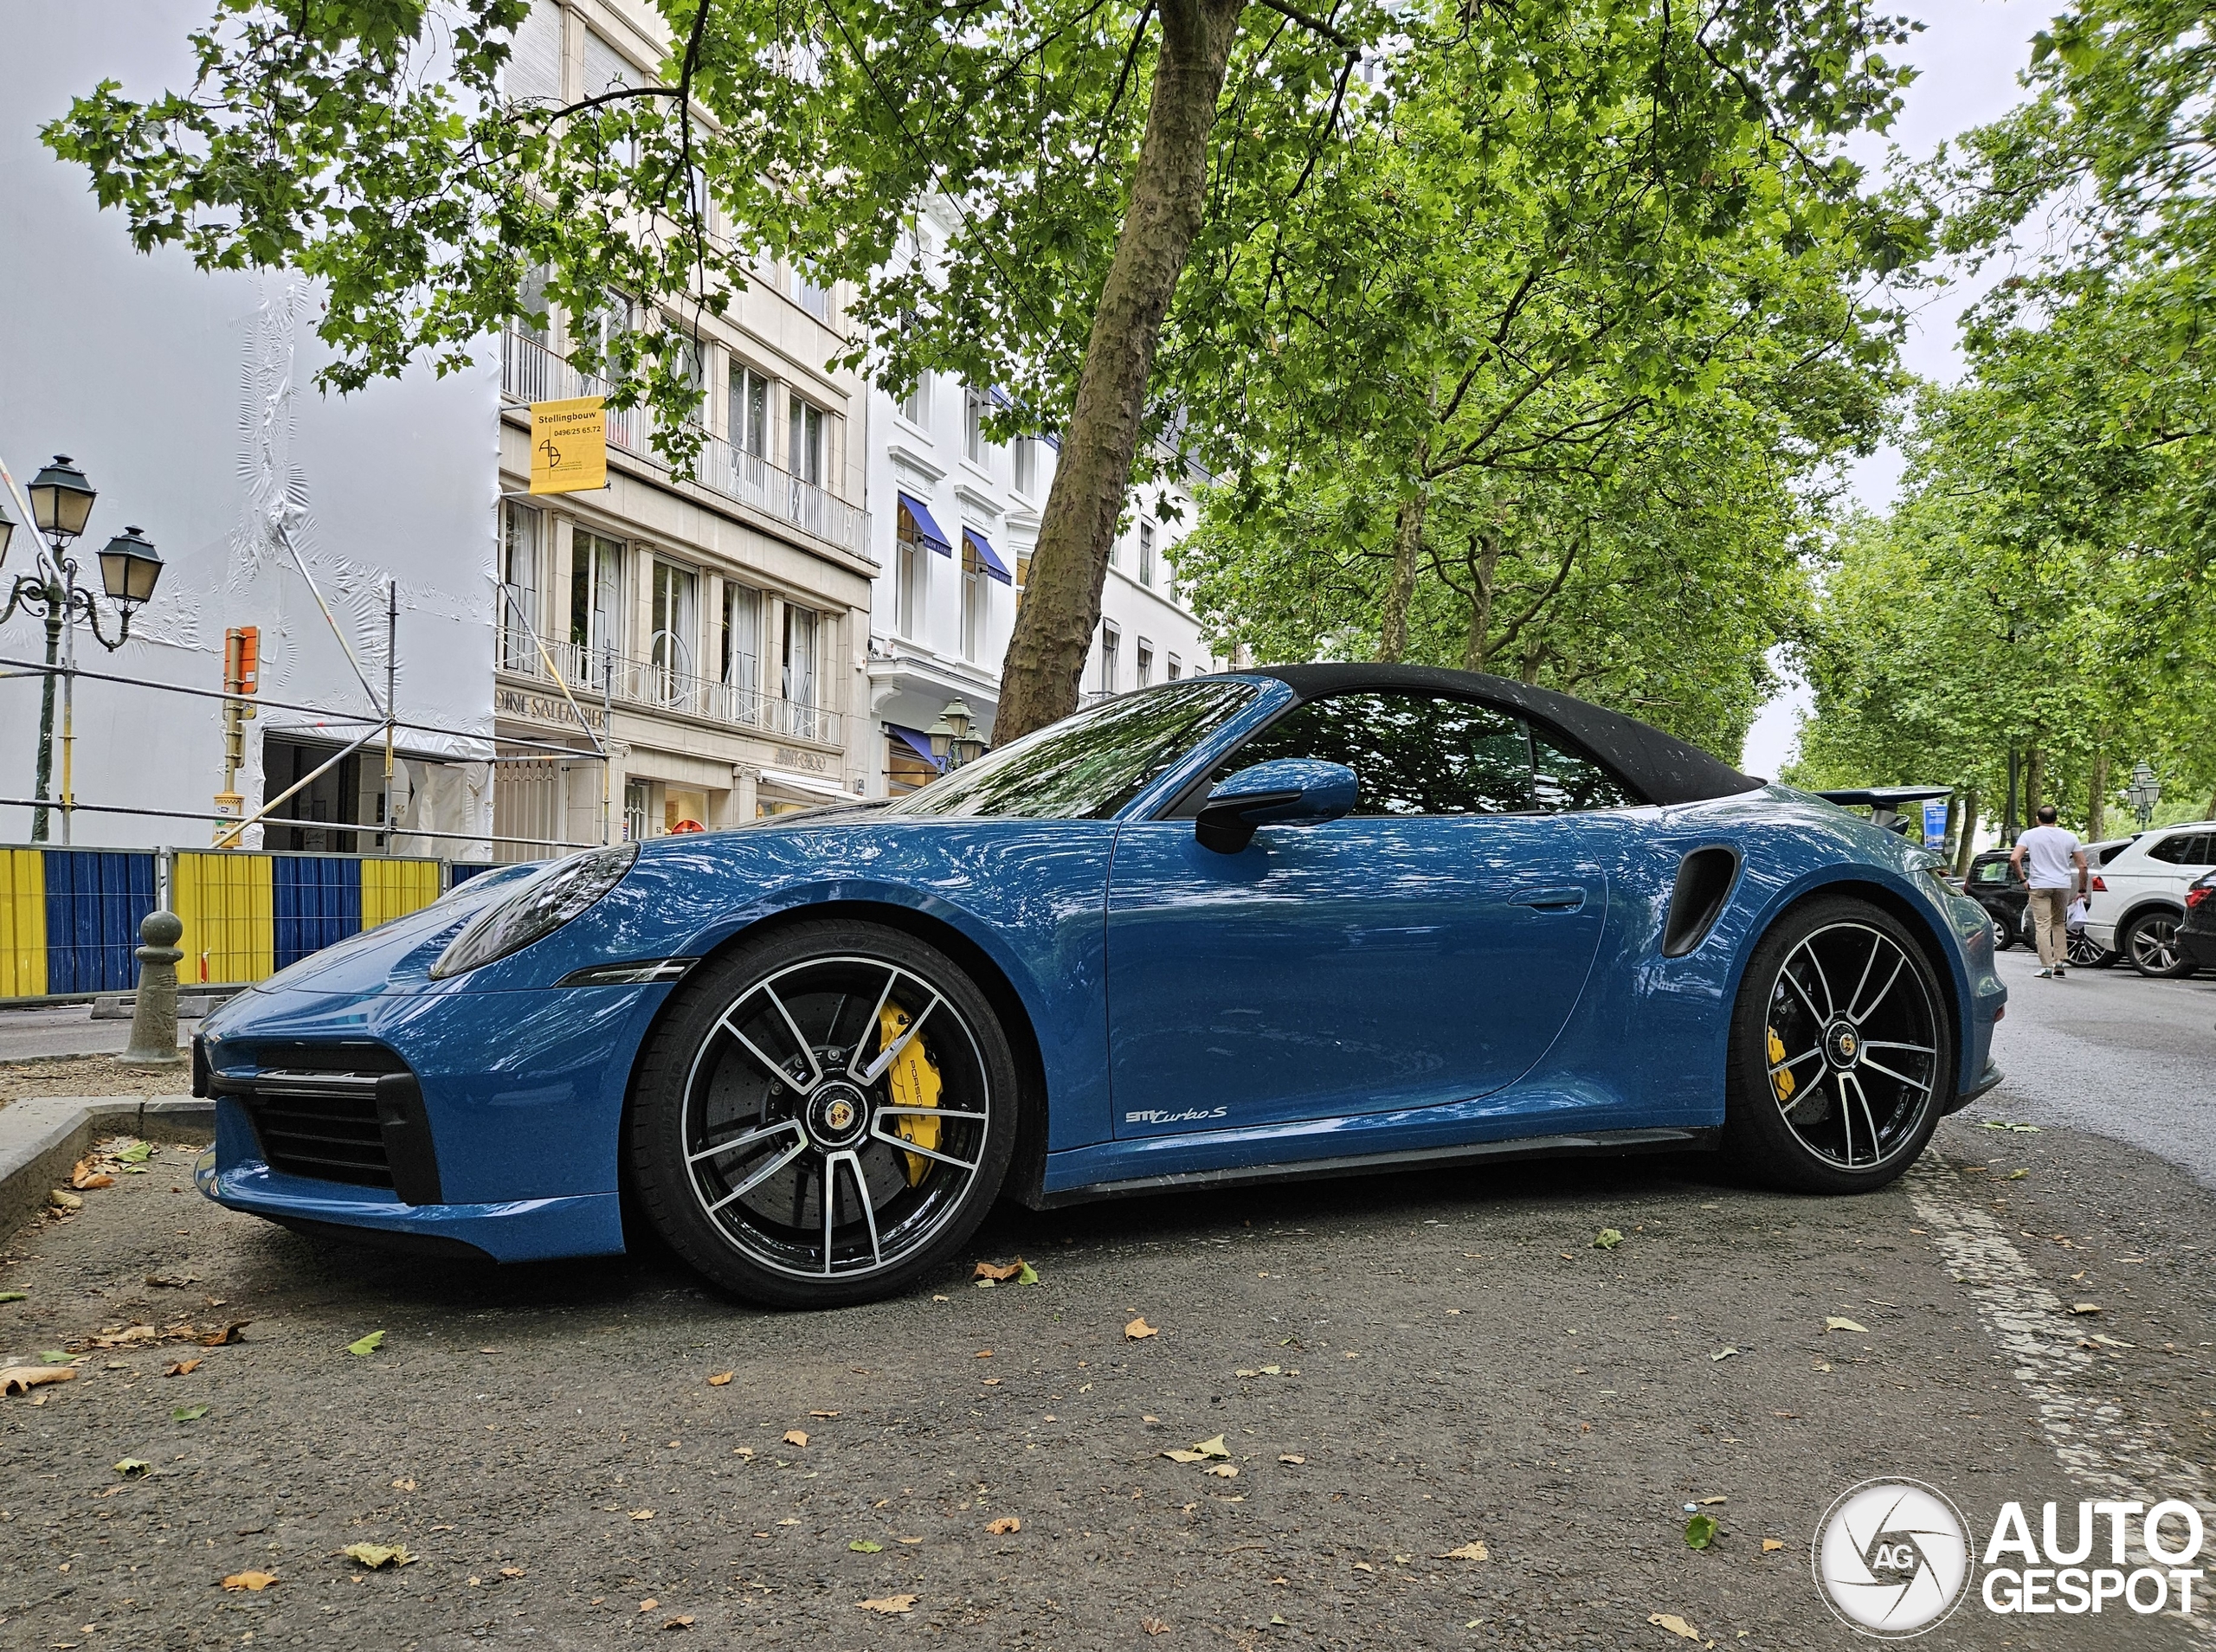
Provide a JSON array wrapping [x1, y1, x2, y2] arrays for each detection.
[[0, 977, 2216, 1652]]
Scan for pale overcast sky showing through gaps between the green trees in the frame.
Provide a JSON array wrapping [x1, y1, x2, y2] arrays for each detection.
[[1740, 0, 2058, 775]]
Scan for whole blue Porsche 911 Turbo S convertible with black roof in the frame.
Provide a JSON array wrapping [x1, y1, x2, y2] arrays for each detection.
[[193, 665, 2006, 1307]]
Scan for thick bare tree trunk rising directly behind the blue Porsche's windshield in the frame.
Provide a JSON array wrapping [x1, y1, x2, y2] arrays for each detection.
[[993, 0, 1246, 744]]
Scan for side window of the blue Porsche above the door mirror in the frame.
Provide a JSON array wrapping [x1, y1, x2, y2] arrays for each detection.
[[1212, 691, 1531, 815]]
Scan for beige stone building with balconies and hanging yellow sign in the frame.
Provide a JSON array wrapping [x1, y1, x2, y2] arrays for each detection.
[[494, 0, 878, 857]]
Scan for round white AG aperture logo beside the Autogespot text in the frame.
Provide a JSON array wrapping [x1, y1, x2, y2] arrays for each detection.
[[1813, 1479, 1970, 1641]]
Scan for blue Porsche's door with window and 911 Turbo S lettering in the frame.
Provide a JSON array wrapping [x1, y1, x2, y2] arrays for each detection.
[[1108, 691, 1631, 1136]]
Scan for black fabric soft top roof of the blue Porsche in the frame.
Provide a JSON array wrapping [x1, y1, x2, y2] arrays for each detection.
[[1227, 665, 1762, 804]]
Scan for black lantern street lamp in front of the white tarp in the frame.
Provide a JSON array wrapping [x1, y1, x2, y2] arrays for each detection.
[[0, 454, 162, 844]]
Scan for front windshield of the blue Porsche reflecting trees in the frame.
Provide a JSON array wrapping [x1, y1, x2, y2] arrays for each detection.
[[884, 678, 1261, 820]]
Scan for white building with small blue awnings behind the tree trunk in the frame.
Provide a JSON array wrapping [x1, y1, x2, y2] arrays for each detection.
[[858, 209, 1221, 795]]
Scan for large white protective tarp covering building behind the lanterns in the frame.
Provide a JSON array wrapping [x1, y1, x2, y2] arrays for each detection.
[[0, 0, 499, 859]]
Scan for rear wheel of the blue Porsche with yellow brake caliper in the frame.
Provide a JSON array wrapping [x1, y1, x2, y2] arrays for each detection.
[[1724, 897, 1955, 1193]]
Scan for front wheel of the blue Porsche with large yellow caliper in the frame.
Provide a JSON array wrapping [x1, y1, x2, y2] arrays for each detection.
[[625, 919, 1017, 1308]]
